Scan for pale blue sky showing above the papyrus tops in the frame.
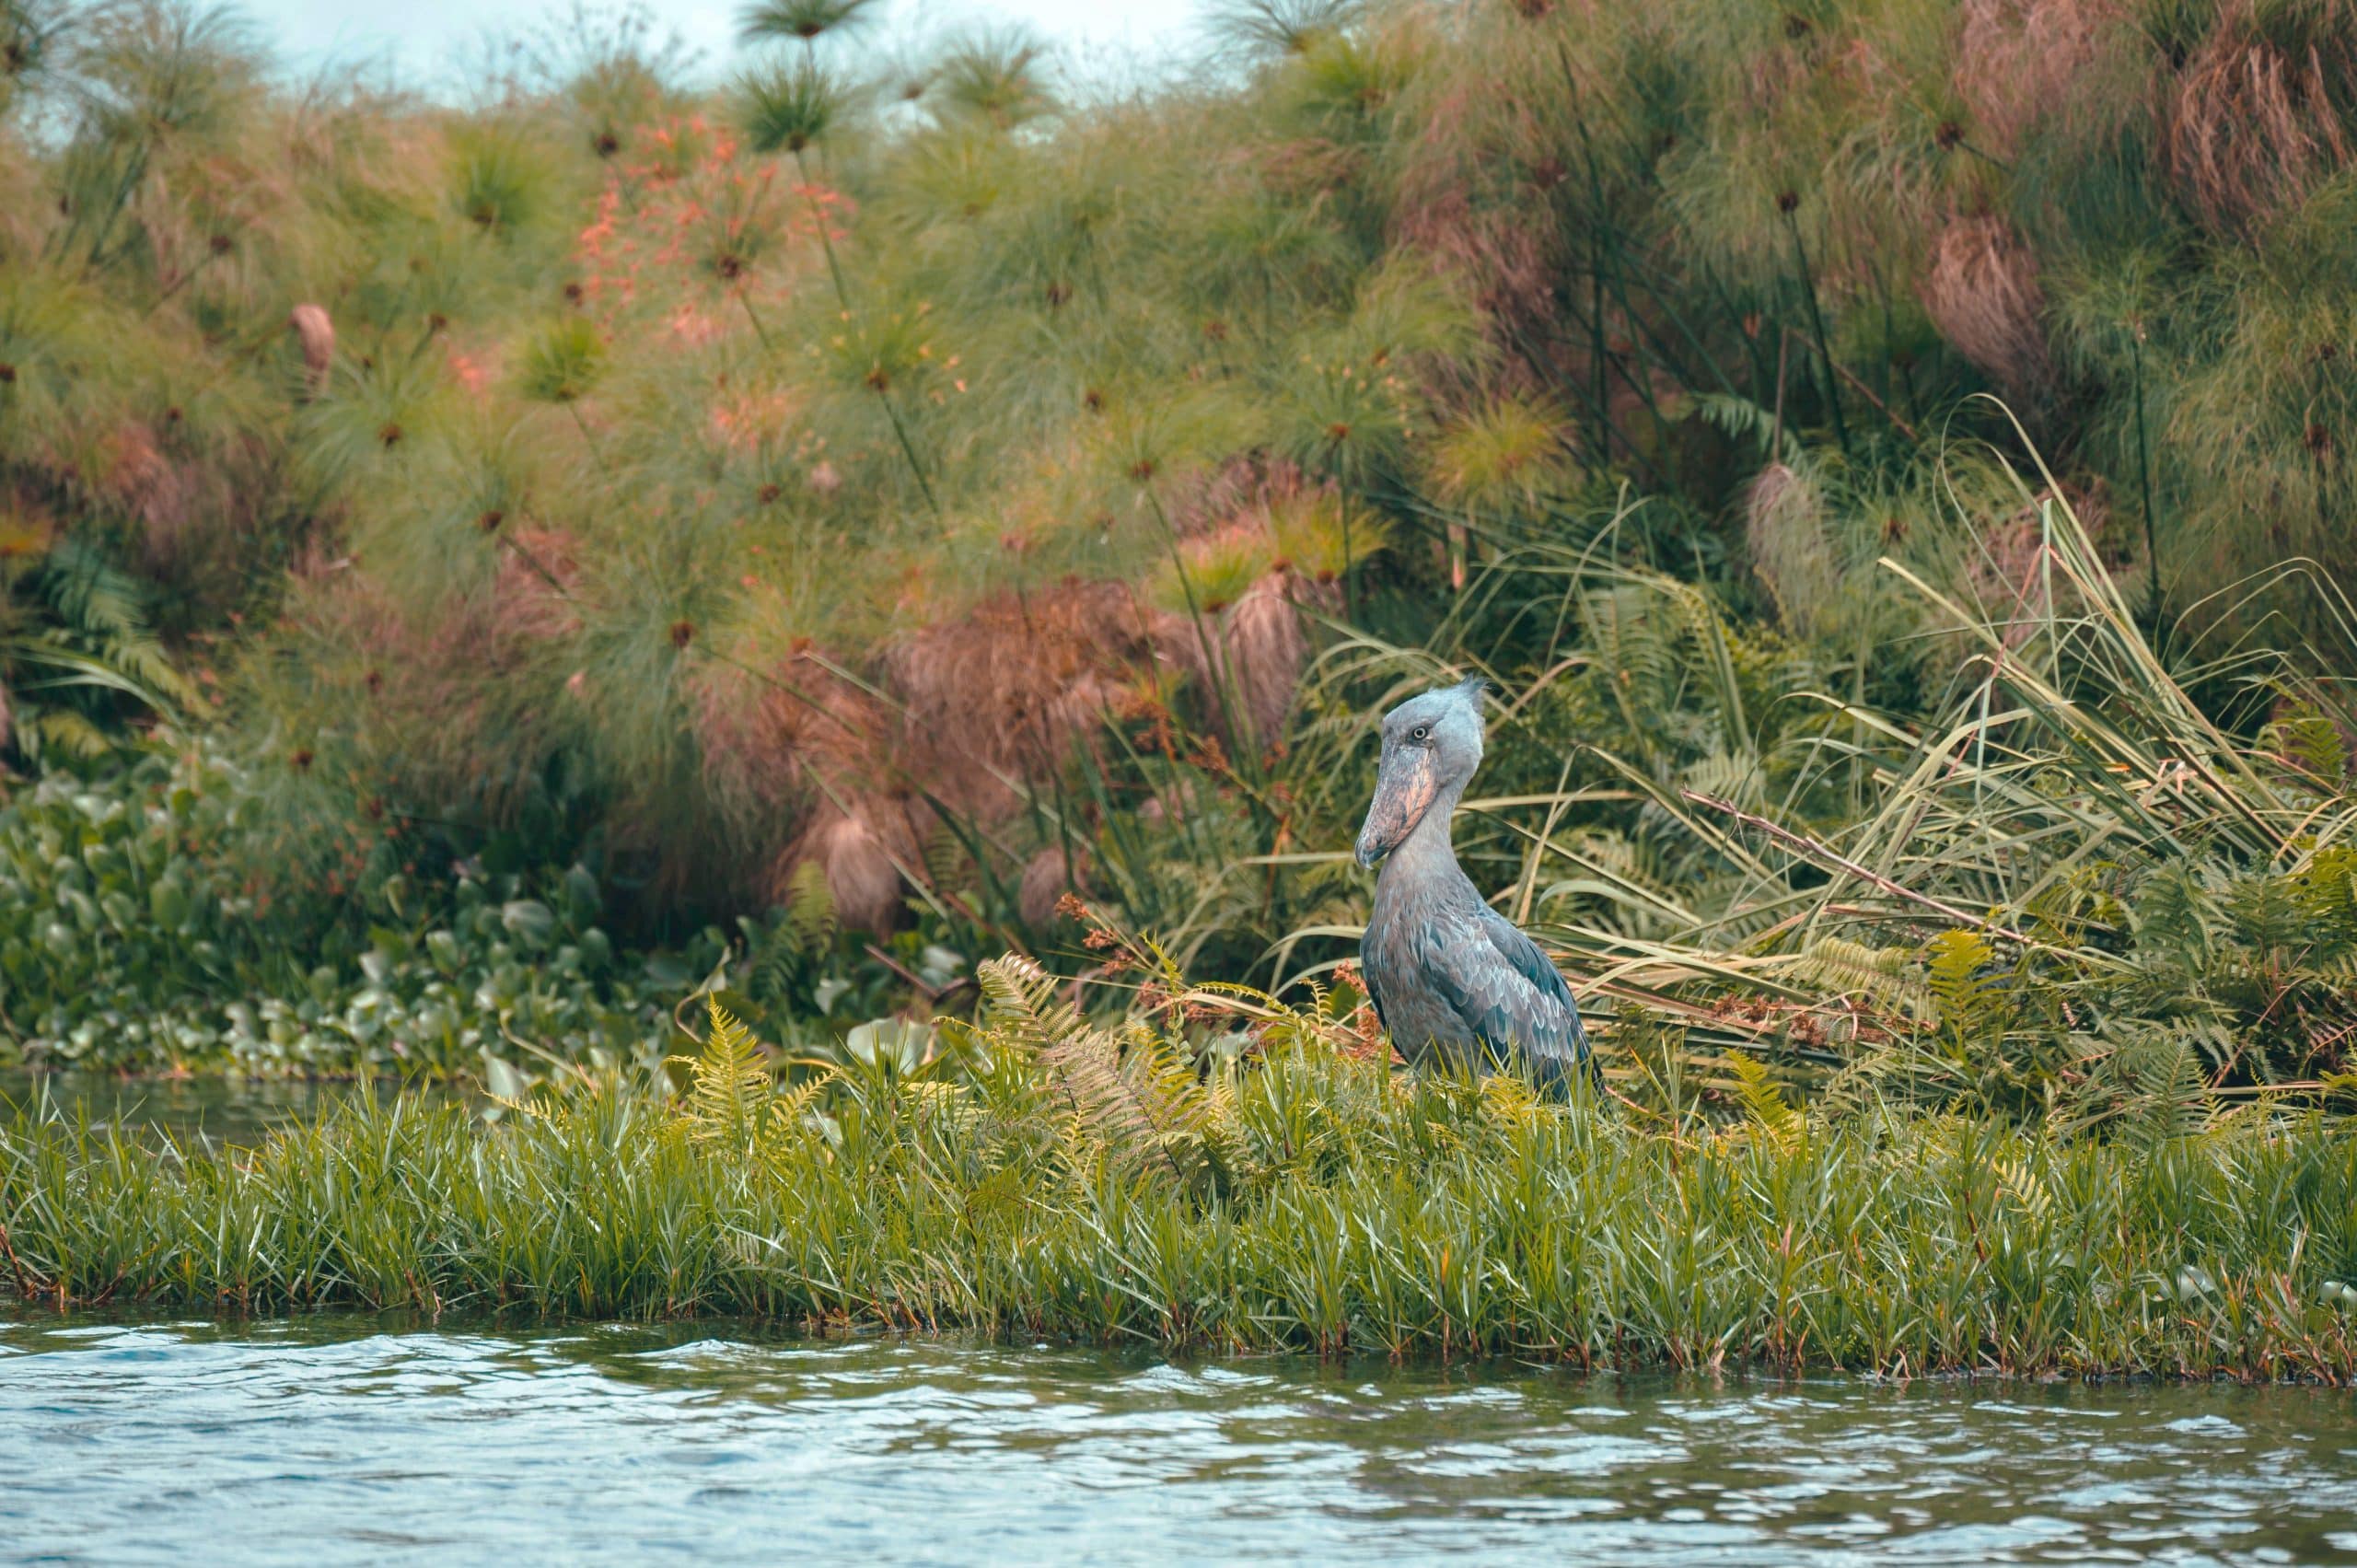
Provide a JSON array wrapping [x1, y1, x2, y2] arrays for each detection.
[[238, 0, 1204, 89]]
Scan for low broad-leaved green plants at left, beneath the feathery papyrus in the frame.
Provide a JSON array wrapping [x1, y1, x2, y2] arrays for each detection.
[[0, 748, 674, 1073]]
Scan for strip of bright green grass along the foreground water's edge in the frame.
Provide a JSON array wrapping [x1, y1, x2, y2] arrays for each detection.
[[0, 994, 2357, 1382]]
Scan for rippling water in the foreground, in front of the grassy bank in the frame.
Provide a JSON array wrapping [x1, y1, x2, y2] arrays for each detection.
[[0, 1308, 2357, 1565]]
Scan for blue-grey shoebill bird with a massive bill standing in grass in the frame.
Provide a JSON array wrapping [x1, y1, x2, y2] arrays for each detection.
[[1358, 677, 1594, 1094]]
